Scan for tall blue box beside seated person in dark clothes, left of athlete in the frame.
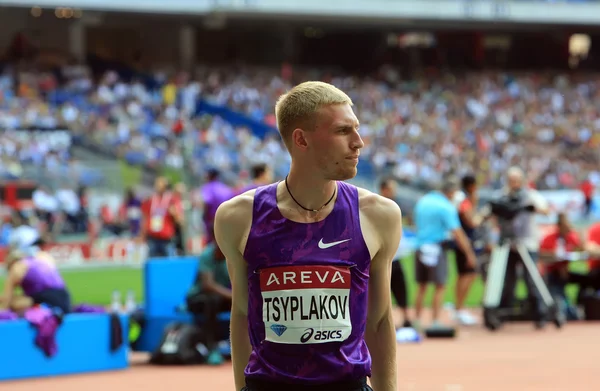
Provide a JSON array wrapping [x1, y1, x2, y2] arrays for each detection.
[[134, 257, 229, 352]]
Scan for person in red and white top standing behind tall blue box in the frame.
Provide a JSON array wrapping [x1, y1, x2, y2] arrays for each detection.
[[140, 177, 183, 257]]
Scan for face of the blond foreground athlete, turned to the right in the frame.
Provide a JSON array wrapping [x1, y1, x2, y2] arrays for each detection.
[[304, 104, 365, 181]]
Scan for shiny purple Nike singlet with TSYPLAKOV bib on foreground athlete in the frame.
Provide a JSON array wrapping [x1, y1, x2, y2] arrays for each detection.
[[244, 182, 371, 385]]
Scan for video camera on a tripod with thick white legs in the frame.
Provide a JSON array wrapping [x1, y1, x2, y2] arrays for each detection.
[[483, 191, 565, 330]]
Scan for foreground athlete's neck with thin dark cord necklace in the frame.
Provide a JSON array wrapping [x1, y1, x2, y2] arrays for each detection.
[[287, 166, 336, 210]]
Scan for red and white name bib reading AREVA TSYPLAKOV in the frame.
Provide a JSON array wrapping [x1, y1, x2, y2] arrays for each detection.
[[260, 265, 352, 344]]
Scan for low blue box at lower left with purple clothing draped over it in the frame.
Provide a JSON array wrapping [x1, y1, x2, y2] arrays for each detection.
[[0, 314, 129, 382]]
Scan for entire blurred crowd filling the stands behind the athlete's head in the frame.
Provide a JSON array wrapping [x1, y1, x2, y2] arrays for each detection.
[[0, 59, 600, 193]]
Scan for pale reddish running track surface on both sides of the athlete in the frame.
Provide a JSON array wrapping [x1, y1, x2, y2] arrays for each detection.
[[0, 322, 600, 391]]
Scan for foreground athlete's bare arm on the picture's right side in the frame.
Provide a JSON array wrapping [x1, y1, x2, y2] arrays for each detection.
[[361, 194, 402, 391]]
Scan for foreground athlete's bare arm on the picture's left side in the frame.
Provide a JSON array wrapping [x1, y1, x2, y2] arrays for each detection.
[[215, 193, 253, 391]]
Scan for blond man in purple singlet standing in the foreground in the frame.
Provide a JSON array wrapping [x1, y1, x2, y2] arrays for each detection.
[[215, 82, 402, 391]]
